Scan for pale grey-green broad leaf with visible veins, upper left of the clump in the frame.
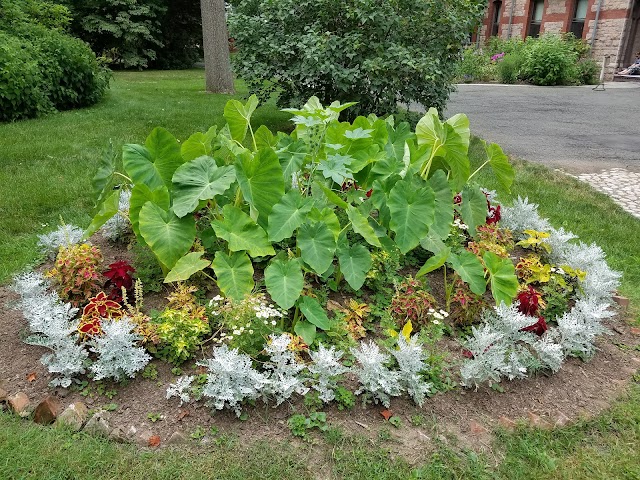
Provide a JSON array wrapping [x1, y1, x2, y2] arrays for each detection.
[[172, 157, 236, 217]]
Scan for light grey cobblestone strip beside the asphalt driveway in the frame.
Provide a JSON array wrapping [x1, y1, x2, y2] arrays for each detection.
[[577, 168, 640, 218]]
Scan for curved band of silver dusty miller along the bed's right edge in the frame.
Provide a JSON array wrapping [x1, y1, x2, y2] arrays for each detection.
[[460, 198, 621, 387]]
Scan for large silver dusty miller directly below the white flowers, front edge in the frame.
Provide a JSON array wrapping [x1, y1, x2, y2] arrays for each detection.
[[198, 345, 269, 417]]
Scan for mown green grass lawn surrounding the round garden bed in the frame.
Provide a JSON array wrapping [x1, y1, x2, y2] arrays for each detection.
[[0, 70, 640, 480]]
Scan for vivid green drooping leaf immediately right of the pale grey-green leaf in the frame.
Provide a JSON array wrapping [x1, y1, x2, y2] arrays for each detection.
[[235, 148, 284, 228]]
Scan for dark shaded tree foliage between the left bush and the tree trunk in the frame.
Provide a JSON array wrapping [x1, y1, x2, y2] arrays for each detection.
[[67, 0, 167, 68]]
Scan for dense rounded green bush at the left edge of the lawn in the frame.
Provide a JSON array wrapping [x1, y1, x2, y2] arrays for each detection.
[[0, 0, 109, 121]]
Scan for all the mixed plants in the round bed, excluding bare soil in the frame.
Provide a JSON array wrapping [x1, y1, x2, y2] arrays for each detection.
[[14, 97, 619, 416]]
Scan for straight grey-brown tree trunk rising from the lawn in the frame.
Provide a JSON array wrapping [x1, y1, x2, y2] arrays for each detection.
[[200, 0, 235, 93]]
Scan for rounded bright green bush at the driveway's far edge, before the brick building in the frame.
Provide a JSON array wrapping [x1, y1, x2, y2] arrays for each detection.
[[522, 35, 578, 85]]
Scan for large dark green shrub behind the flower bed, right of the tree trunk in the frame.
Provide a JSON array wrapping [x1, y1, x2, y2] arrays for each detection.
[[228, 0, 485, 116]]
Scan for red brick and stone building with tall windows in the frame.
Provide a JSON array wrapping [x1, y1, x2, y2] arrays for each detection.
[[478, 0, 640, 73]]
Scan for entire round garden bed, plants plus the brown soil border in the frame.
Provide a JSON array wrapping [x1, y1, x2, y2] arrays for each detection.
[[0, 97, 638, 458]]
